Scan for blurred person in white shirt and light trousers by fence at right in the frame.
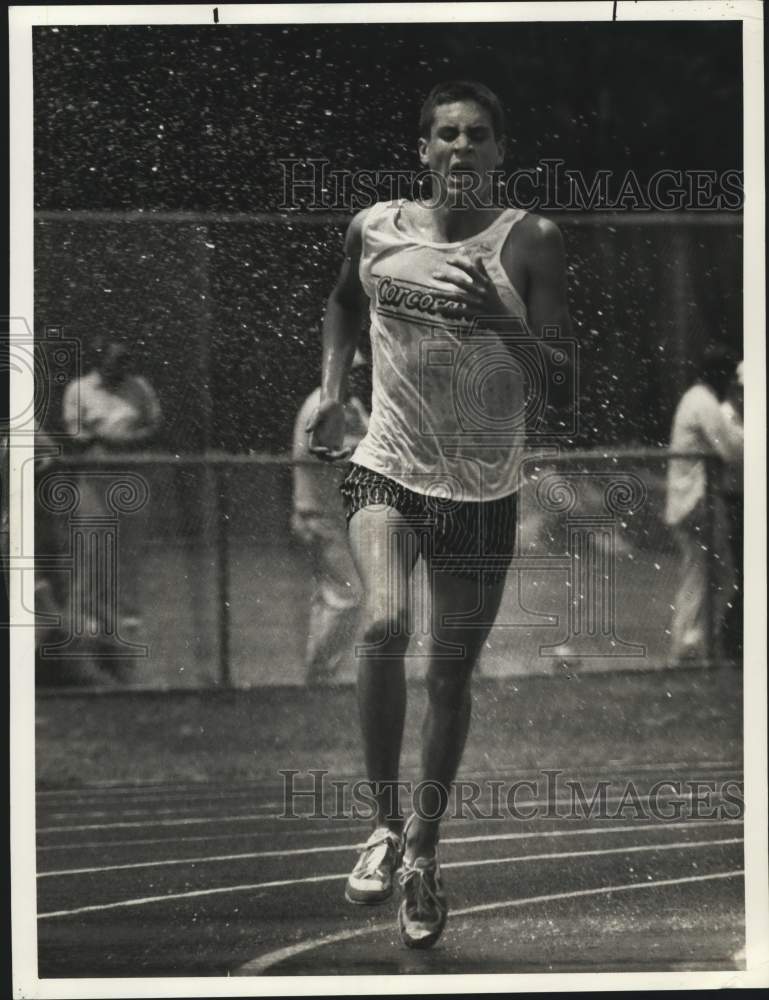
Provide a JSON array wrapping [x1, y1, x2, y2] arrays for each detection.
[[665, 346, 743, 664]]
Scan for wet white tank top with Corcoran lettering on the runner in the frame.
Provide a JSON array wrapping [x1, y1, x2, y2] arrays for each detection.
[[352, 200, 528, 501]]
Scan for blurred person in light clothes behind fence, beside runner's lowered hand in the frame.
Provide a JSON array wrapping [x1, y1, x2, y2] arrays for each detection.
[[291, 351, 371, 685]]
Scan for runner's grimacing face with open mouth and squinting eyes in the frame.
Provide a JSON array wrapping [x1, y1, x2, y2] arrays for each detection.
[[419, 101, 504, 201]]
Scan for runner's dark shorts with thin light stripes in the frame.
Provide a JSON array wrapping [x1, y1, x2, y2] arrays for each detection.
[[339, 463, 518, 586]]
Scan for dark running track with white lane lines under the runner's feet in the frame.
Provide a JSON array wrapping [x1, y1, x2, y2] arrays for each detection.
[[37, 761, 744, 978]]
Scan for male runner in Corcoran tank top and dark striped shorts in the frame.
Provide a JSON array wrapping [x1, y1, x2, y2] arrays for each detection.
[[308, 81, 570, 948]]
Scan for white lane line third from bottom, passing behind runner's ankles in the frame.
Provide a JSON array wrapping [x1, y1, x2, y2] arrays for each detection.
[[37, 819, 742, 878]]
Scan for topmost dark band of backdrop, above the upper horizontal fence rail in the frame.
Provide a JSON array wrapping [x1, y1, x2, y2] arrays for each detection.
[[35, 22, 742, 211]]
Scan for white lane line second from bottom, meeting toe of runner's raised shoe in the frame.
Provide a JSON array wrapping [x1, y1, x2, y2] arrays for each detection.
[[38, 837, 743, 920]]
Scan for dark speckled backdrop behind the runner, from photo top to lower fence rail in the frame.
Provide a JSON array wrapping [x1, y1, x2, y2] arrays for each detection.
[[34, 22, 742, 451]]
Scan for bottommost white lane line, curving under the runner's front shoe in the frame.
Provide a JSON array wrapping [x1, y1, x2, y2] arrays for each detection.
[[233, 869, 745, 976]]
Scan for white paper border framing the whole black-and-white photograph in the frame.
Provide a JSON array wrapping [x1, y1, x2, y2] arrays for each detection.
[[9, 0, 769, 998]]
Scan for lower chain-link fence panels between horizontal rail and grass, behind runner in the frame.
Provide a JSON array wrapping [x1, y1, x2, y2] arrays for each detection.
[[25, 449, 736, 689]]
